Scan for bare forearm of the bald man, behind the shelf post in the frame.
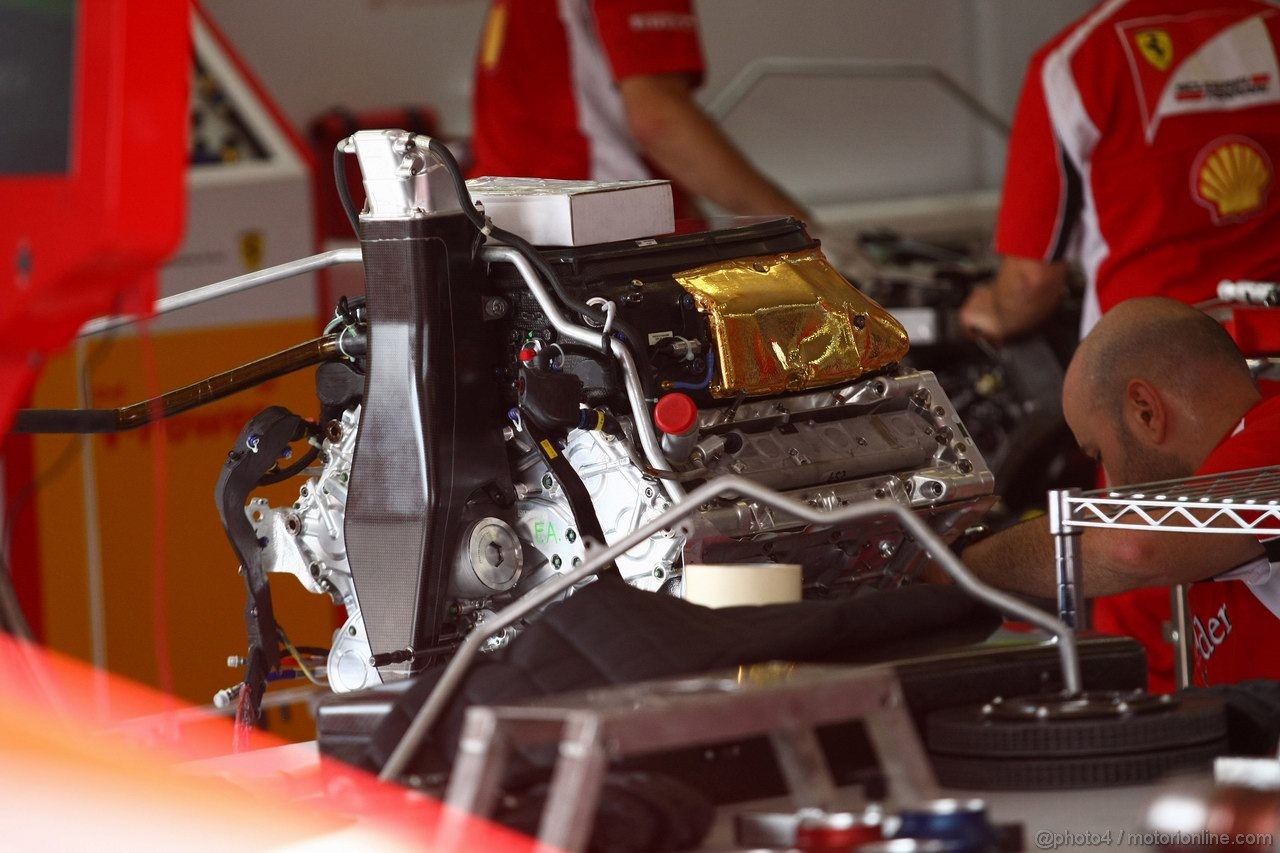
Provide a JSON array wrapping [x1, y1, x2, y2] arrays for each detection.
[[960, 517, 1263, 598]]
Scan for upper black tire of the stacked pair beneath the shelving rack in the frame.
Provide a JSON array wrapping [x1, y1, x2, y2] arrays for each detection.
[[925, 697, 1226, 761]]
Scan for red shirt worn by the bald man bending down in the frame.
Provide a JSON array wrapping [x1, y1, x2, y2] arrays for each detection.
[[1189, 397, 1280, 686]]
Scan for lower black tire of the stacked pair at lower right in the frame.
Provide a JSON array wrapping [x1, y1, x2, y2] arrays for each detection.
[[932, 739, 1228, 790]]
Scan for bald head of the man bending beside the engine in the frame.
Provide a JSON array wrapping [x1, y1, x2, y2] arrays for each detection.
[[1062, 298, 1258, 485]]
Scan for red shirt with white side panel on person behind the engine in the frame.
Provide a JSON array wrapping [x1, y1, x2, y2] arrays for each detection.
[[471, 0, 703, 181]]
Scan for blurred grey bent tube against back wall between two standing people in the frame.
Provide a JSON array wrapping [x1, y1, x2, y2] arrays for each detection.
[[707, 56, 1009, 137]]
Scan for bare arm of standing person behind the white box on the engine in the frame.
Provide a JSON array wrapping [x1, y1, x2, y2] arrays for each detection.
[[618, 74, 809, 220]]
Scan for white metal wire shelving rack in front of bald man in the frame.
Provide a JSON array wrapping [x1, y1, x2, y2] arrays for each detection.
[[1048, 465, 1280, 686]]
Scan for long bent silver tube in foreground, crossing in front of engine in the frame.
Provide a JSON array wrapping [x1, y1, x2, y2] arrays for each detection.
[[378, 475, 1080, 780]]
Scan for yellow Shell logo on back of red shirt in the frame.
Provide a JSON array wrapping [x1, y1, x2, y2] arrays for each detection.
[[1192, 136, 1274, 223]]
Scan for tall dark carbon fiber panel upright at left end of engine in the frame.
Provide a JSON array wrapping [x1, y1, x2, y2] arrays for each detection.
[[346, 214, 509, 674]]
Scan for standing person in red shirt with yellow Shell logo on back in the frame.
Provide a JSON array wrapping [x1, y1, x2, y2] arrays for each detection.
[[960, 0, 1280, 690]]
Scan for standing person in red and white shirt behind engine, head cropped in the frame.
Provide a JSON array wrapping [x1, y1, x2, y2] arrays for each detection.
[[471, 0, 808, 219]]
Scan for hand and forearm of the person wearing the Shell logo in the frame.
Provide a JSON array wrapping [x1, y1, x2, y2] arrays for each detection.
[[960, 256, 1066, 343]]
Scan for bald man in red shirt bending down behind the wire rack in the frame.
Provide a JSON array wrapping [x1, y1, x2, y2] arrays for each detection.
[[961, 297, 1280, 685]]
